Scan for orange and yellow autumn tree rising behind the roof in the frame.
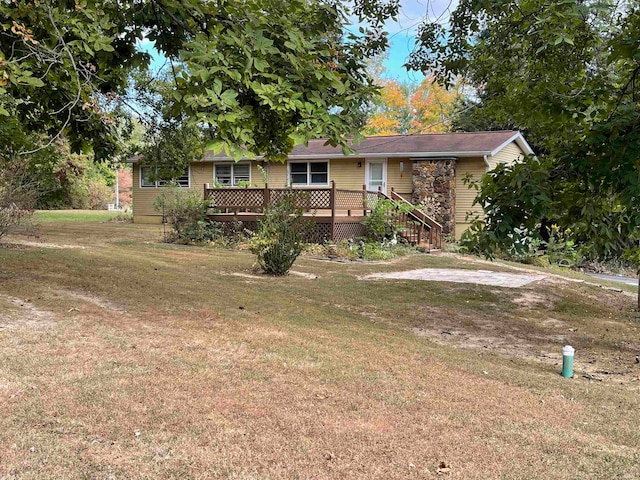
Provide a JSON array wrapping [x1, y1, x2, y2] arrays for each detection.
[[364, 77, 461, 136]]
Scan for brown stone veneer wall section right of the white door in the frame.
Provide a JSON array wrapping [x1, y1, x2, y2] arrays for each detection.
[[411, 158, 456, 234]]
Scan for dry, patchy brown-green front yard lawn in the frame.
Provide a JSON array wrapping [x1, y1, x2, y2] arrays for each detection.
[[0, 222, 640, 479]]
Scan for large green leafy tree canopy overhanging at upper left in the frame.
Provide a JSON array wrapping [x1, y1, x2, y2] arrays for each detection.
[[0, 0, 397, 162]]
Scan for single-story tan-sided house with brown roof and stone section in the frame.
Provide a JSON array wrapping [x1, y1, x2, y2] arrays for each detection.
[[130, 131, 533, 238]]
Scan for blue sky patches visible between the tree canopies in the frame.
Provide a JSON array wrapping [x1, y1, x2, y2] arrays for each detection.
[[140, 0, 457, 82]]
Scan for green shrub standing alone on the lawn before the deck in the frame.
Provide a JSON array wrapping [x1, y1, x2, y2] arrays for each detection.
[[250, 195, 311, 275]]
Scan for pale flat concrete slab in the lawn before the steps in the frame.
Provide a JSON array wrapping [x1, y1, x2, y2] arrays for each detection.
[[360, 268, 545, 288]]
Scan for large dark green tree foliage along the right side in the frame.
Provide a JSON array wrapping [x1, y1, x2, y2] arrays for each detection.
[[408, 0, 640, 264]]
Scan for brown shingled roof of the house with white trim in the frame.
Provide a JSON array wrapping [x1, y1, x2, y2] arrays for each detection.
[[129, 130, 533, 162]]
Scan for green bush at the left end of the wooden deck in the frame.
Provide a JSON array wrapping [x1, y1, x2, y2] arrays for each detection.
[[153, 186, 221, 243]]
